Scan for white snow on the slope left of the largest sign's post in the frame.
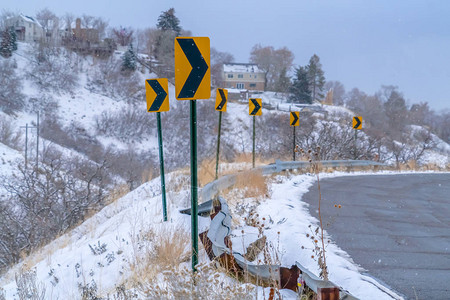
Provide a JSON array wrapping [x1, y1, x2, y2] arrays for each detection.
[[0, 171, 209, 299]]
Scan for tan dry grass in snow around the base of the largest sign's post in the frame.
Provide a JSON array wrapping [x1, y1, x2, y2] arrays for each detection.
[[123, 224, 254, 300]]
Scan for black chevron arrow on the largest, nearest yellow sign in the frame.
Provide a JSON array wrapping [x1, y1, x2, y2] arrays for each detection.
[[177, 39, 208, 98]]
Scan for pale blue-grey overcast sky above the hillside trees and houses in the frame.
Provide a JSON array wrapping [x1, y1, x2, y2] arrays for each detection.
[[4, 0, 450, 110]]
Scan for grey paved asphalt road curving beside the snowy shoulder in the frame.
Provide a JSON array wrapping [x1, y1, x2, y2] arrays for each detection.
[[302, 173, 450, 299]]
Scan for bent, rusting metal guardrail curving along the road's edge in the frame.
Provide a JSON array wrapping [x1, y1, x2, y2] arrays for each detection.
[[180, 160, 384, 300]]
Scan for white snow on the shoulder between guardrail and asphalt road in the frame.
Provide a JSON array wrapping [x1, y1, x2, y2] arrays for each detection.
[[232, 172, 410, 299]]
